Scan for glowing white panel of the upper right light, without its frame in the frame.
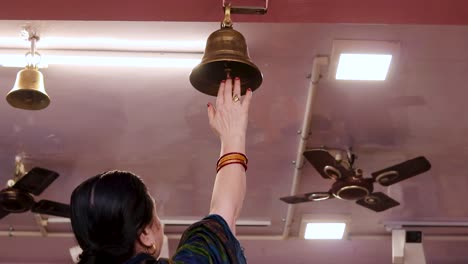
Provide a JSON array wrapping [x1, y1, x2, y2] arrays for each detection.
[[335, 53, 392, 81]]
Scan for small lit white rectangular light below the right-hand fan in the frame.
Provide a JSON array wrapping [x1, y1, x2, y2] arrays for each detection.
[[304, 223, 346, 239]]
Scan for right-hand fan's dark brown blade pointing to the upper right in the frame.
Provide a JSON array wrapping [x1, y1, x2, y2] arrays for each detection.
[[372, 157, 431, 186]]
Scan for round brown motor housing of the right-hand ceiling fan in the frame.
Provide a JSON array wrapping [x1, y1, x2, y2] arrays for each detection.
[[332, 177, 374, 200]]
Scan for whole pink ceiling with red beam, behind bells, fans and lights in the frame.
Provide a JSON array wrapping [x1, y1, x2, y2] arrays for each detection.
[[0, 0, 468, 264]]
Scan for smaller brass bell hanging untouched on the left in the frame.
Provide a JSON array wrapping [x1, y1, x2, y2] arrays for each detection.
[[6, 66, 50, 110]]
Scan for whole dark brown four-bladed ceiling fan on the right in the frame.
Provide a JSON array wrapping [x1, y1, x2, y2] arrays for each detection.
[[280, 148, 431, 212]]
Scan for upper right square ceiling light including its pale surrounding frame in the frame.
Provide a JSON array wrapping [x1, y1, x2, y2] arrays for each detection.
[[329, 40, 400, 81]]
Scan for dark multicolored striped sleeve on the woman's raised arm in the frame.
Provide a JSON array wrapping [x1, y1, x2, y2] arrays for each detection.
[[172, 215, 247, 264]]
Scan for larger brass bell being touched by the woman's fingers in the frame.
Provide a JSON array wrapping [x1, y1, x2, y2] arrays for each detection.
[[190, 6, 263, 96]]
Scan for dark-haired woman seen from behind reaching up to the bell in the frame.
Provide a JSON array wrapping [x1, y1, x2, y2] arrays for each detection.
[[70, 78, 252, 264]]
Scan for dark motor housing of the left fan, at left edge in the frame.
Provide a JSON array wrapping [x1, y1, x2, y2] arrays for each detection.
[[0, 188, 34, 213]]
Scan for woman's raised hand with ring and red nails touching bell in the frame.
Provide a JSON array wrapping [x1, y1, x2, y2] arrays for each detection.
[[208, 78, 252, 145]]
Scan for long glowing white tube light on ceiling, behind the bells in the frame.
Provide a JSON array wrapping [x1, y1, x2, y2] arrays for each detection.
[[0, 50, 203, 68]]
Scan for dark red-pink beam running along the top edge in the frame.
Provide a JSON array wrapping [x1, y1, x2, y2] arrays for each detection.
[[0, 0, 468, 25]]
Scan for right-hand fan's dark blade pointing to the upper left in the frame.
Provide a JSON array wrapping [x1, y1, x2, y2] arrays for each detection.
[[304, 149, 352, 179]]
